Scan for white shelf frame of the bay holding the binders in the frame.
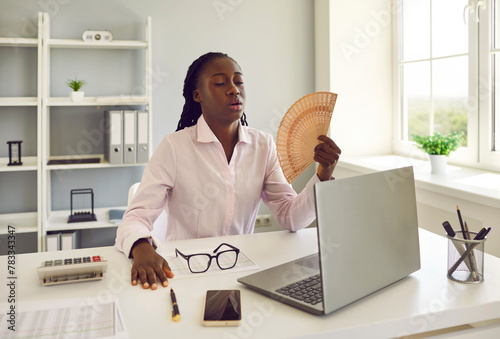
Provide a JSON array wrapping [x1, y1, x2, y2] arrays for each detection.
[[41, 13, 153, 249]]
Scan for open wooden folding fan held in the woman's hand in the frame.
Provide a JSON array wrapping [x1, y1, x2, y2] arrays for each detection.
[[276, 92, 337, 183]]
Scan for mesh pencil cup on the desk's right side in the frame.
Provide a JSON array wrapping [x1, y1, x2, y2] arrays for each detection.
[[447, 231, 486, 284]]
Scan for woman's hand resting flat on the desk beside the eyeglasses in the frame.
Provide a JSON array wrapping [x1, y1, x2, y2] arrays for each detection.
[[131, 239, 174, 290]]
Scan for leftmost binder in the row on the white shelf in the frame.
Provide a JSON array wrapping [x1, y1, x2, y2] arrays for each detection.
[[104, 111, 123, 164]]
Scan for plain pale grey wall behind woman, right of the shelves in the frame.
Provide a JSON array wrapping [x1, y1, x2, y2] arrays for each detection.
[[122, 0, 314, 149]]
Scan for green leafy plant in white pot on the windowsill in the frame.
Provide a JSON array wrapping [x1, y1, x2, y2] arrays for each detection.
[[411, 132, 463, 174]]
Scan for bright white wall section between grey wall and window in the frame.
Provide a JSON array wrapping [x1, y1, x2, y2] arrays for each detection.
[[316, 0, 392, 155]]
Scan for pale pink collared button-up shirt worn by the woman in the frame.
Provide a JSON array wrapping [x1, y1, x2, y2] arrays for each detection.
[[116, 116, 319, 255]]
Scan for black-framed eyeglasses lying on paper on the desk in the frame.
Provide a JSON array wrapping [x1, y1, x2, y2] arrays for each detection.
[[175, 243, 240, 273]]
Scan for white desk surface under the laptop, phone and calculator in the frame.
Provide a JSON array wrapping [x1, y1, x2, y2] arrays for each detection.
[[0, 229, 500, 339]]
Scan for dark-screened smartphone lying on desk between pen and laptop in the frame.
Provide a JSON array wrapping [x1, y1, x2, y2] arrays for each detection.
[[203, 290, 241, 326]]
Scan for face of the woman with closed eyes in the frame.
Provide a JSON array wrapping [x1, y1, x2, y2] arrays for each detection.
[[193, 58, 245, 126]]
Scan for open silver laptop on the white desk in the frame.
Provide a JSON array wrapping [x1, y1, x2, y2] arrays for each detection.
[[238, 167, 420, 314]]
